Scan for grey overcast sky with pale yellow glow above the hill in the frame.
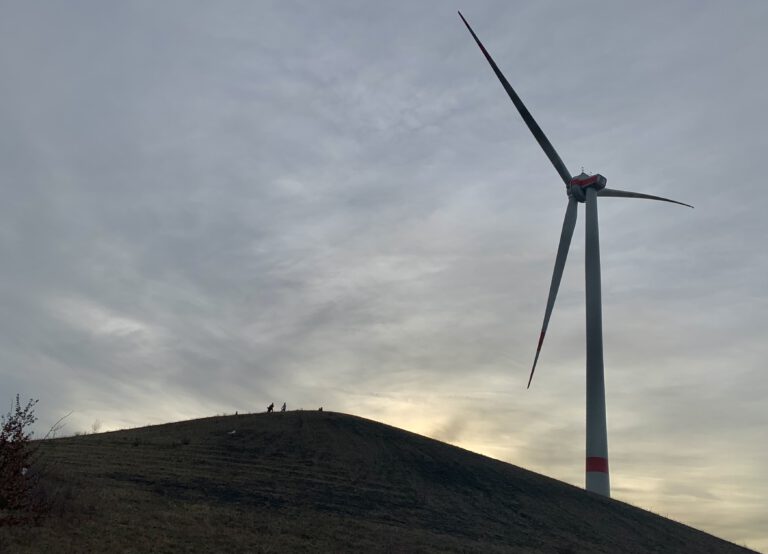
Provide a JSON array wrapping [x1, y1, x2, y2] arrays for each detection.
[[0, 0, 768, 549]]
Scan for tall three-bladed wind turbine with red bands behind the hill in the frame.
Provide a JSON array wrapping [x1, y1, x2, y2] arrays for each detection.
[[459, 12, 693, 497]]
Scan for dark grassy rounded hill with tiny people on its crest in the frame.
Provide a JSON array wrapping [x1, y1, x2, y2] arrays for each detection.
[[0, 412, 749, 554]]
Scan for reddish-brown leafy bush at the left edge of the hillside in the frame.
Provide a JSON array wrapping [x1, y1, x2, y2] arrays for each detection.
[[0, 394, 43, 525]]
